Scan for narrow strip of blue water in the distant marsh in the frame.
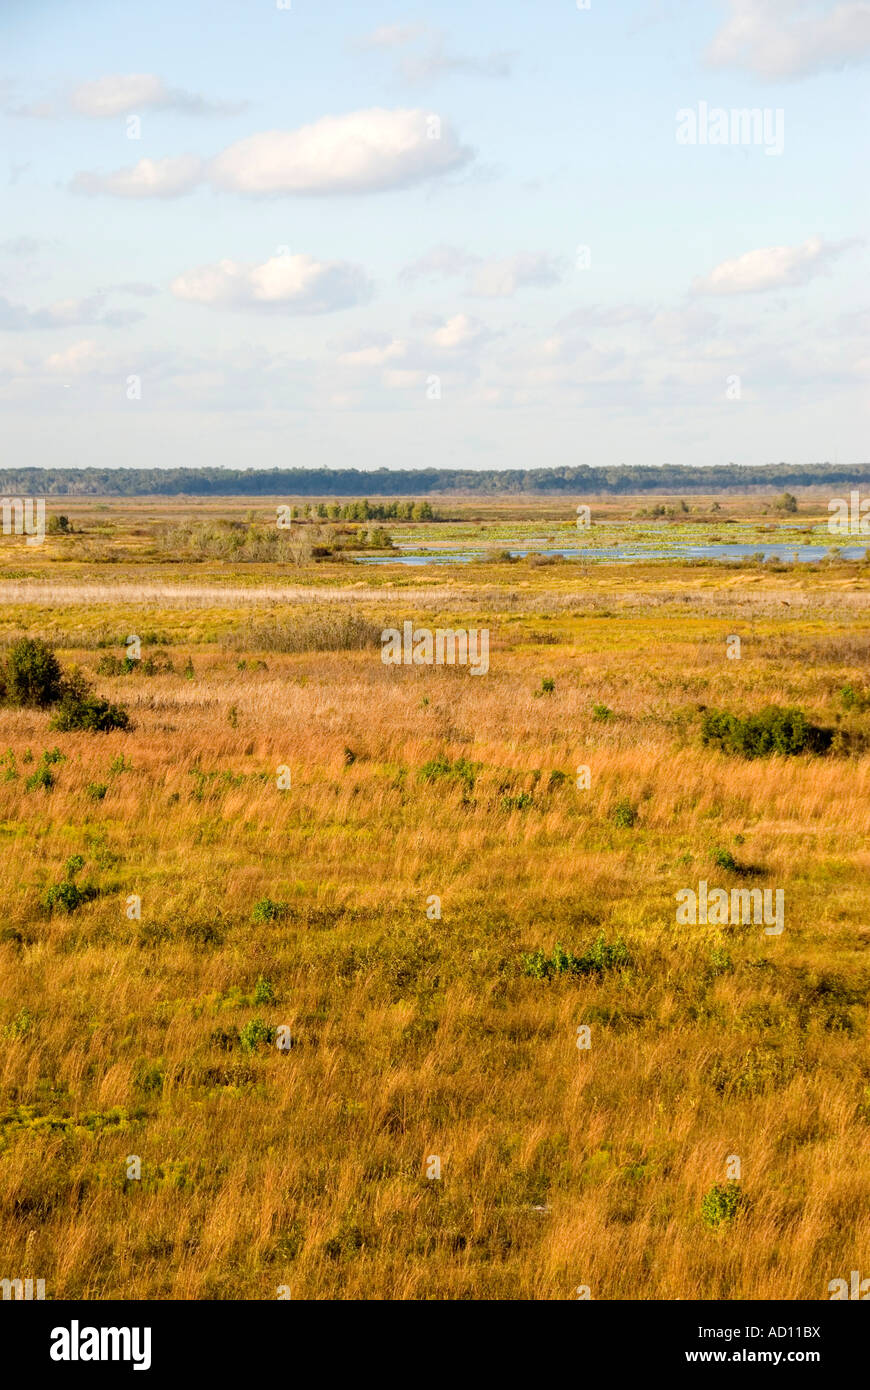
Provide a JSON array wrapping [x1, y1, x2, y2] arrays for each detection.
[[354, 541, 867, 564]]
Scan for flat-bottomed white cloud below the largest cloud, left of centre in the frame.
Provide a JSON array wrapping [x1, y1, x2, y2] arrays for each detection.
[[170, 254, 371, 314]]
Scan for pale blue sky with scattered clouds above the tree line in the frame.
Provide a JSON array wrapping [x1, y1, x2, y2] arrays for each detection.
[[0, 0, 870, 468]]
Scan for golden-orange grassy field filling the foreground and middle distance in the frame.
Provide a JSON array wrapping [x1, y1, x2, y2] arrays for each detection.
[[0, 499, 870, 1300]]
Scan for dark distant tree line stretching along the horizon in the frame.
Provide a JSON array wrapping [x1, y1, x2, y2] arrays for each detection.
[[0, 463, 870, 498]]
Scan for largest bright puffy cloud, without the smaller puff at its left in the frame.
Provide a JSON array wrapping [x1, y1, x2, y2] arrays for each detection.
[[210, 107, 471, 195]]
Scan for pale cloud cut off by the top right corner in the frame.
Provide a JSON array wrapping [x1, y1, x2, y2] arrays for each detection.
[[706, 0, 870, 78]]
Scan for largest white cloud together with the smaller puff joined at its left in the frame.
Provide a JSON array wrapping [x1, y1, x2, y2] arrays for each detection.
[[71, 107, 474, 197]]
